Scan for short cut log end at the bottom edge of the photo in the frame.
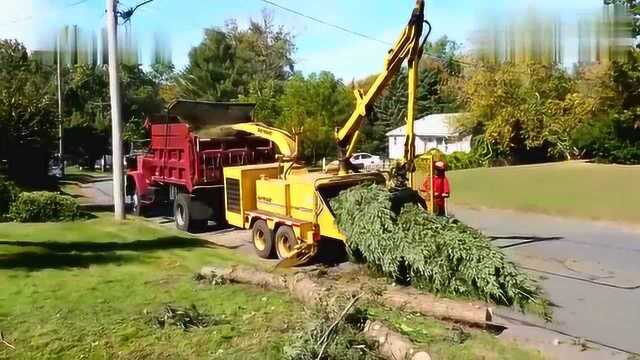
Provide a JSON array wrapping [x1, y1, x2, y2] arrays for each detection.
[[363, 321, 431, 360]]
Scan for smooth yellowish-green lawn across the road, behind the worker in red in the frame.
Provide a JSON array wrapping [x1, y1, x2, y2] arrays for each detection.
[[440, 162, 640, 224]]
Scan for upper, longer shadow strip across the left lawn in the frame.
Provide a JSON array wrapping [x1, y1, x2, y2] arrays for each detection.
[[0, 236, 215, 253]]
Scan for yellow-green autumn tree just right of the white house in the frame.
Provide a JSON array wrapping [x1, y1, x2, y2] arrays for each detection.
[[461, 64, 604, 163]]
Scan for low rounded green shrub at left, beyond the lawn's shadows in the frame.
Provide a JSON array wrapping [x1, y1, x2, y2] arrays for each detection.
[[9, 191, 80, 222]]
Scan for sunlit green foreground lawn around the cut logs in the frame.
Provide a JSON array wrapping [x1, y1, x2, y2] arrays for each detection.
[[0, 216, 541, 359]]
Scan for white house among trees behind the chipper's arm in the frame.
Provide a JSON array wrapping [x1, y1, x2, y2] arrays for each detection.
[[387, 113, 471, 159]]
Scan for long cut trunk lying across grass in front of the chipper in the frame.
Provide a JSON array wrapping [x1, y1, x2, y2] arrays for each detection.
[[200, 266, 493, 327]]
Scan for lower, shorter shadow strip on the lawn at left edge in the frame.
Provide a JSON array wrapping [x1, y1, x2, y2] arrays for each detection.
[[0, 252, 136, 270]]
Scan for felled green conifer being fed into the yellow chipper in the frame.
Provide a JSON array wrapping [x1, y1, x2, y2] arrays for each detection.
[[331, 185, 542, 309]]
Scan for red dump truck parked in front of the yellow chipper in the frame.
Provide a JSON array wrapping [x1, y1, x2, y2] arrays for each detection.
[[125, 100, 278, 232]]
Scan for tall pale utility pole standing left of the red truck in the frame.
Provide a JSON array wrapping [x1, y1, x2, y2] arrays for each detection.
[[106, 0, 125, 221]]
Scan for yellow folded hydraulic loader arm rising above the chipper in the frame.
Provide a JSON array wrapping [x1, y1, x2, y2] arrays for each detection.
[[336, 0, 429, 186]]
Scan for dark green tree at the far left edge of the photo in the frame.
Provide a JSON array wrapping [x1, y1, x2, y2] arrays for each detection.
[[0, 40, 57, 184]]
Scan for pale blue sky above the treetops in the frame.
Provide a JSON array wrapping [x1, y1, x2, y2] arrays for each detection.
[[0, 0, 602, 81]]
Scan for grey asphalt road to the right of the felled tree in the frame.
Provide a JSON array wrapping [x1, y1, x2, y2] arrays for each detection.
[[452, 208, 640, 353]]
